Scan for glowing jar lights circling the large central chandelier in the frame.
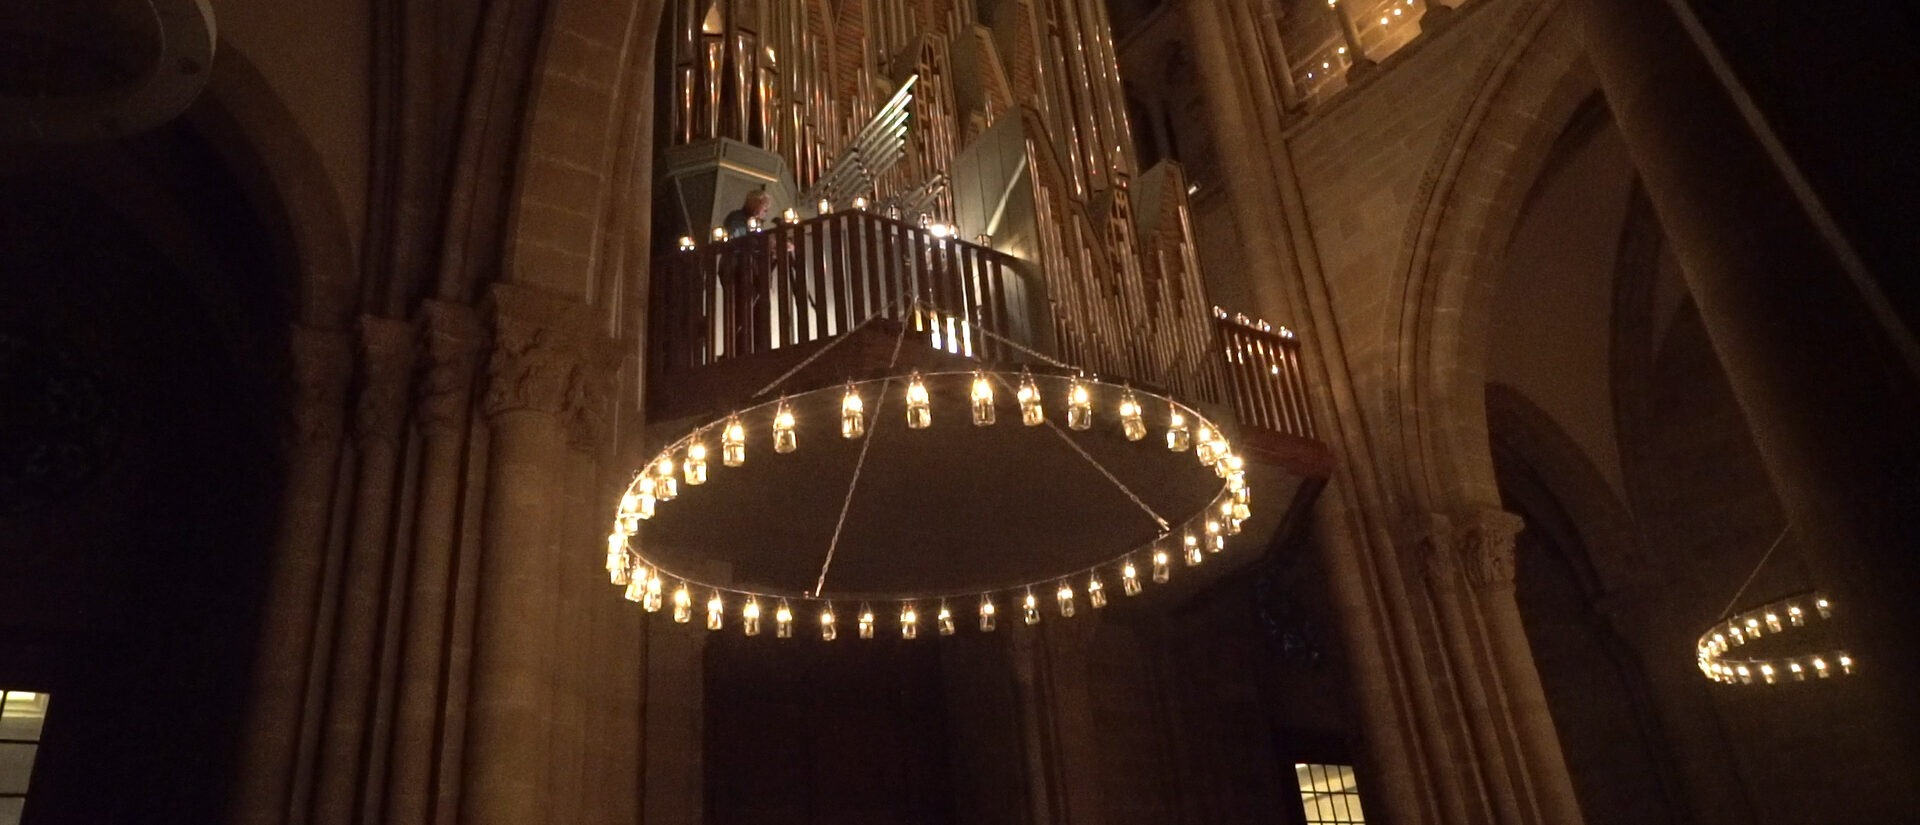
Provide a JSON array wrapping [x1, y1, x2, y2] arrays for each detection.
[[607, 368, 1252, 639]]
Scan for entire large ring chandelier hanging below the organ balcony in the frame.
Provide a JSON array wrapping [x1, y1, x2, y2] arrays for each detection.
[[607, 318, 1252, 641]]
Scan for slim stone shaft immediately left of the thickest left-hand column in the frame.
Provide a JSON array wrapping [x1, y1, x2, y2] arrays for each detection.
[[384, 301, 484, 825]]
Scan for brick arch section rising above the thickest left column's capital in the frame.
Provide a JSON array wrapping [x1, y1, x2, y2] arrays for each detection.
[[501, 0, 666, 307]]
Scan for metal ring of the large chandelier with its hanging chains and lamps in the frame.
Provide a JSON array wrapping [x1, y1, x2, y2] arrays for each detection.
[[607, 368, 1252, 637]]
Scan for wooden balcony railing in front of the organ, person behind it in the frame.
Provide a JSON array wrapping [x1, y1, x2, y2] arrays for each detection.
[[651, 211, 1031, 374]]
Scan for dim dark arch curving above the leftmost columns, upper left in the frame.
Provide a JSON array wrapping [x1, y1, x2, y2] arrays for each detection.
[[186, 48, 361, 328]]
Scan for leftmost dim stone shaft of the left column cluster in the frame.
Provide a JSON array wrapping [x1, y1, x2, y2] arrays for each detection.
[[232, 324, 353, 825]]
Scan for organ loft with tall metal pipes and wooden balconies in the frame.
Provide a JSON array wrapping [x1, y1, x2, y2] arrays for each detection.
[[647, 0, 1331, 541]]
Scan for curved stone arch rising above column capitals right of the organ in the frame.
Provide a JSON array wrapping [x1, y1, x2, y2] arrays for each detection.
[[1382, 0, 1597, 512]]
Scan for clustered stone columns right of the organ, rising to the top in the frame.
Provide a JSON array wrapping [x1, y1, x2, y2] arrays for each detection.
[[1183, 0, 1580, 823]]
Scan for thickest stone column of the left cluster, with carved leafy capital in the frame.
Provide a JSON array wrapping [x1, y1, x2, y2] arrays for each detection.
[[459, 286, 593, 825]]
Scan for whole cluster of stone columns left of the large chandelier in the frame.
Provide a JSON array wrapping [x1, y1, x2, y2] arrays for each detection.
[[223, 286, 629, 825]]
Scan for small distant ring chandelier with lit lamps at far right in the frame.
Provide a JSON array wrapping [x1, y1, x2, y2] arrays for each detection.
[[1693, 593, 1855, 685]]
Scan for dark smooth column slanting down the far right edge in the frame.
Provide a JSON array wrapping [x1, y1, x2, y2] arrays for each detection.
[[1571, 0, 1920, 759]]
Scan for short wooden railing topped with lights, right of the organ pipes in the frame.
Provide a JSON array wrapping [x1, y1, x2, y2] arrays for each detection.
[[1215, 313, 1319, 437]]
